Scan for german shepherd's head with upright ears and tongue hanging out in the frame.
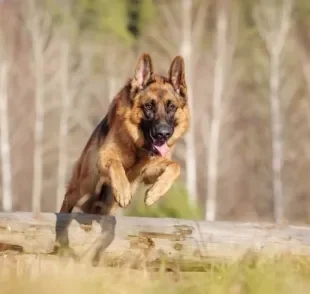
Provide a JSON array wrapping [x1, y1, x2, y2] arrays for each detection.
[[123, 54, 189, 156]]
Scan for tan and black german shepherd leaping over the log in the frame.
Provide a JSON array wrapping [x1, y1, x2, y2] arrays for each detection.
[[55, 53, 190, 248]]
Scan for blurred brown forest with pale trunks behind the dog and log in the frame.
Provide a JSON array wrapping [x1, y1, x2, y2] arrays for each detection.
[[0, 0, 310, 223]]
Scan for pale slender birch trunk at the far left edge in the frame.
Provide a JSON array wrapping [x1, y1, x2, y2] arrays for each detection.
[[0, 56, 13, 211]]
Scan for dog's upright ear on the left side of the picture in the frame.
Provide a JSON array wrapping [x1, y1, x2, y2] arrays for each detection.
[[133, 53, 153, 89]]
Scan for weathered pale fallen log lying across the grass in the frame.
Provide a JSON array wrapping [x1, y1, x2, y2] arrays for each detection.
[[0, 212, 310, 270]]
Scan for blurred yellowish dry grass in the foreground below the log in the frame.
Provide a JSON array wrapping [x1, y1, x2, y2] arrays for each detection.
[[0, 254, 310, 294]]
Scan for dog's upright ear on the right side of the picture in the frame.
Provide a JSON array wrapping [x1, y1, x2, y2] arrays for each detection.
[[168, 56, 187, 98]]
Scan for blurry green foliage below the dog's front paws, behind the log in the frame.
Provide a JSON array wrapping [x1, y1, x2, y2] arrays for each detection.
[[125, 183, 202, 219]]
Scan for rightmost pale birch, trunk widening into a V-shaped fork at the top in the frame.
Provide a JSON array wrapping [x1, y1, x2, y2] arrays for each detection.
[[254, 0, 293, 223]]
